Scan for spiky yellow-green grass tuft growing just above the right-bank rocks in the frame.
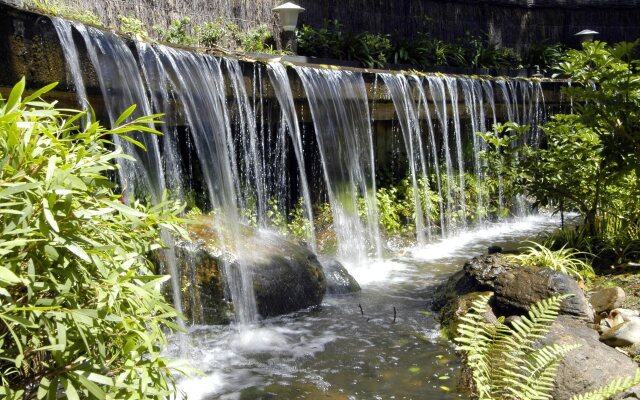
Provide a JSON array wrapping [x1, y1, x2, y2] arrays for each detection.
[[509, 242, 595, 281]]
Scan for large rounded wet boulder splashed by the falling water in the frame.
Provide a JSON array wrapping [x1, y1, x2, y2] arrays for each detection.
[[156, 217, 326, 324]]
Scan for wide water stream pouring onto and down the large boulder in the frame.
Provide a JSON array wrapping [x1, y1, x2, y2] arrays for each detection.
[[143, 46, 257, 326]]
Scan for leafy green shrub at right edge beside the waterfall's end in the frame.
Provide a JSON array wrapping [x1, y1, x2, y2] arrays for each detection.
[[481, 41, 640, 258]]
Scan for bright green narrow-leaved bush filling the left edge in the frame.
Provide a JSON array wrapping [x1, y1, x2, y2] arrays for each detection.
[[0, 79, 184, 399]]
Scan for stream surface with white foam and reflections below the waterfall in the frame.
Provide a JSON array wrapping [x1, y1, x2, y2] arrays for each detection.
[[170, 216, 558, 400]]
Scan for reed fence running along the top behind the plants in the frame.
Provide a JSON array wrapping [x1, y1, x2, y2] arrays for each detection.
[[6, 0, 640, 48]]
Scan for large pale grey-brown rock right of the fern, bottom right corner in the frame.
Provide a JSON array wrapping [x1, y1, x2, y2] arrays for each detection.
[[541, 315, 638, 400]]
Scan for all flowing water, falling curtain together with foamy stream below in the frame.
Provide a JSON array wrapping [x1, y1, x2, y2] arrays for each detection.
[[48, 19, 556, 399]]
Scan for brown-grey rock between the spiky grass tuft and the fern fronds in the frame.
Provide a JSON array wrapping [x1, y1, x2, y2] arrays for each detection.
[[494, 268, 593, 321]]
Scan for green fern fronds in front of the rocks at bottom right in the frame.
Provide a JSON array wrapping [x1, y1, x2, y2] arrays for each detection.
[[455, 295, 640, 400]]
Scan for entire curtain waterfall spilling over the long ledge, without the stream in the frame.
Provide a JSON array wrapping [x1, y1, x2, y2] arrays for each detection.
[[53, 18, 544, 326]]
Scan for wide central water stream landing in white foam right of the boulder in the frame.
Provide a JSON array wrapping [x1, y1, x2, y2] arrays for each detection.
[[295, 67, 382, 266]]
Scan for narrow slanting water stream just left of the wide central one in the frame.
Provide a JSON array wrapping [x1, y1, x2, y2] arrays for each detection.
[[267, 63, 317, 251]]
